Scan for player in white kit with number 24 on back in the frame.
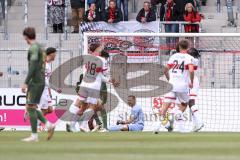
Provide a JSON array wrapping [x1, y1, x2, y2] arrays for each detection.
[[155, 40, 194, 133]]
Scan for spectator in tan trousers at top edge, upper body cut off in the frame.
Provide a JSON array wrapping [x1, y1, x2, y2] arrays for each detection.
[[70, 0, 85, 33]]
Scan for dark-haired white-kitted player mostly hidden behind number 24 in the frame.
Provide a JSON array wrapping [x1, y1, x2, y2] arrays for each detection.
[[188, 48, 204, 132]]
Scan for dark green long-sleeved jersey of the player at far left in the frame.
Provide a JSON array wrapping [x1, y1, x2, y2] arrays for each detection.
[[25, 43, 46, 85]]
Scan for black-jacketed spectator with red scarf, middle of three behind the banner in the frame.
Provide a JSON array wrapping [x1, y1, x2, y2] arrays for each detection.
[[104, 0, 123, 23]]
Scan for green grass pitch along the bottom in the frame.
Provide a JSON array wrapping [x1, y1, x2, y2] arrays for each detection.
[[0, 132, 240, 160]]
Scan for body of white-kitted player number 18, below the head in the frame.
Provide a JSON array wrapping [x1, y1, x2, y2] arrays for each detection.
[[67, 54, 118, 131]]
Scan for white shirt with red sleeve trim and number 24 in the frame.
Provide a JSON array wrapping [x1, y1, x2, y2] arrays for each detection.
[[167, 53, 194, 93]]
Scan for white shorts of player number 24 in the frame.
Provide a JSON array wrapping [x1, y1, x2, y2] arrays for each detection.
[[164, 91, 189, 103]]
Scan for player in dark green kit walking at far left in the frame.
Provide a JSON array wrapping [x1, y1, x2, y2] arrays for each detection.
[[22, 27, 55, 142]]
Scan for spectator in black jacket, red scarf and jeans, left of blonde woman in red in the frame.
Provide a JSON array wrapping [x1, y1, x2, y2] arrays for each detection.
[[160, 0, 181, 52]]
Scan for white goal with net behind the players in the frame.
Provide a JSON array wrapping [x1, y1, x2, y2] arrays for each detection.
[[84, 33, 240, 132]]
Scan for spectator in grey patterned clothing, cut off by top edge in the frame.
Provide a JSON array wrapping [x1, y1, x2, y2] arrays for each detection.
[[48, 0, 65, 33]]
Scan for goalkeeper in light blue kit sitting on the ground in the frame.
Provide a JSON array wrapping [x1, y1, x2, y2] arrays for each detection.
[[108, 95, 144, 132]]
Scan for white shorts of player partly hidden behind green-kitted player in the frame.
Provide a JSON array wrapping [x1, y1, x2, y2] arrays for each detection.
[[38, 87, 52, 109]]
